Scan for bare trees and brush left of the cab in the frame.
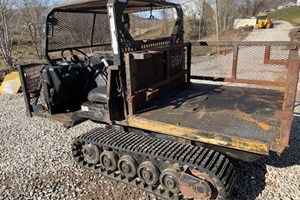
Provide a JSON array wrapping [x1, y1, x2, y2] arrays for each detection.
[[0, 0, 46, 68]]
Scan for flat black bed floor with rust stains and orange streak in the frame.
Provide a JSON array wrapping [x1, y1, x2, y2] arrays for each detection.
[[138, 83, 283, 143]]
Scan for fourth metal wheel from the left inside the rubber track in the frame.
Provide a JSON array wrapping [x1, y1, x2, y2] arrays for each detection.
[[138, 161, 159, 185]]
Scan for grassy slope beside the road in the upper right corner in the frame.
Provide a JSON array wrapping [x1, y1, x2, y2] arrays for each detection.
[[269, 7, 300, 26]]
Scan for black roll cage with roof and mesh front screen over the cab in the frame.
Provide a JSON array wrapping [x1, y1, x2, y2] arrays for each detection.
[[42, 0, 184, 65]]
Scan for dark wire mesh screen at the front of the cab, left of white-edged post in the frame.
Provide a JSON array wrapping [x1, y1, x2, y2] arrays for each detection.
[[48, 11, 110, 51]]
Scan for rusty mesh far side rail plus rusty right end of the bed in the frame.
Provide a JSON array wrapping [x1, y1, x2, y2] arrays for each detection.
[[191, 42, 300, 153]]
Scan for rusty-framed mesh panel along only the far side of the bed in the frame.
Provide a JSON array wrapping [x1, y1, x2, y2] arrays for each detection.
[[191, 42, 300, 90]]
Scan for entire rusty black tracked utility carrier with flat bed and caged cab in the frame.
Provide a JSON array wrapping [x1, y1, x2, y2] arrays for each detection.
[[19, 0, 300, 199]]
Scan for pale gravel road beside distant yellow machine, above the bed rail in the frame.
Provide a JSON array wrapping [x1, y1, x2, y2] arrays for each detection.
[[245, 20, 294, 41]]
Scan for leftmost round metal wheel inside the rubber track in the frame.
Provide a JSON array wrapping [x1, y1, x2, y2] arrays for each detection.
[[82, 144, 101, 164]]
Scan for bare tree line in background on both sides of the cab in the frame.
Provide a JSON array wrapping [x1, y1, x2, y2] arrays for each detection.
[[0, 0, 285, 68]]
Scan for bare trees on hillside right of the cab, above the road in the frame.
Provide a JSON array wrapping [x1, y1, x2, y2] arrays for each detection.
[[182, 0, 286, 40]]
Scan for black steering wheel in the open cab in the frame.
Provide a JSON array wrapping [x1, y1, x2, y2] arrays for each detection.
[[61, 48, 91, 67]]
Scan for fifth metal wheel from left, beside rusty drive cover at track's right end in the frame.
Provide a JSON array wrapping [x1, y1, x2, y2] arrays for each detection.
[[160, 168, 180, 194]]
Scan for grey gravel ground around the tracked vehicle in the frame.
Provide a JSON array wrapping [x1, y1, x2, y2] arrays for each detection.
[[0, 95, 300, 200]]
